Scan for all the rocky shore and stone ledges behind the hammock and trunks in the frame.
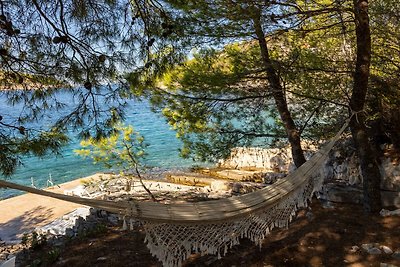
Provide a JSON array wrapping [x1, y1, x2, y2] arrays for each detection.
[[0, 141, 400, 263]]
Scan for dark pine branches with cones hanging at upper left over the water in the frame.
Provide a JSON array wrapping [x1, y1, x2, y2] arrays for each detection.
[[0, 0, 179, 178]]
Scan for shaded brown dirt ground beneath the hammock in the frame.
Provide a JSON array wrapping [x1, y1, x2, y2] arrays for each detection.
[[12, 200, 400, 267]]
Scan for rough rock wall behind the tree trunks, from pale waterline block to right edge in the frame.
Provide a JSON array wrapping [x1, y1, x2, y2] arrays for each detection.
[[218, 139, 400, 206]]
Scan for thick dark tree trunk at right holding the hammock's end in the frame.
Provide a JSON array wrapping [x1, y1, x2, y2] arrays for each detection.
[[350, 0, 381, 212]]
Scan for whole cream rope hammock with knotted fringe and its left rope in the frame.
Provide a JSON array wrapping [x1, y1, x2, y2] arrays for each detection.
[[0, 120, 349, 266]]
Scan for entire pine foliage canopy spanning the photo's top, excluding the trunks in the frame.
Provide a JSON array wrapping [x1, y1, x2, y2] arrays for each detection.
[[0, 0, 400, 175]]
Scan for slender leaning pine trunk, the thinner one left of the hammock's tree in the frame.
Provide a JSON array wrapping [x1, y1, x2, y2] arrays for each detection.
[[253, 16, 306, 167]]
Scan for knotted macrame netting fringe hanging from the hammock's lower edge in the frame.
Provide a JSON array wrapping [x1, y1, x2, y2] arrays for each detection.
[[143, 172, 317, 266]]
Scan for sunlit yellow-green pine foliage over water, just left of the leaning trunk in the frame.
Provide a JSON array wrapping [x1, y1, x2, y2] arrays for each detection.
[[151, 43, 282, 161]]
